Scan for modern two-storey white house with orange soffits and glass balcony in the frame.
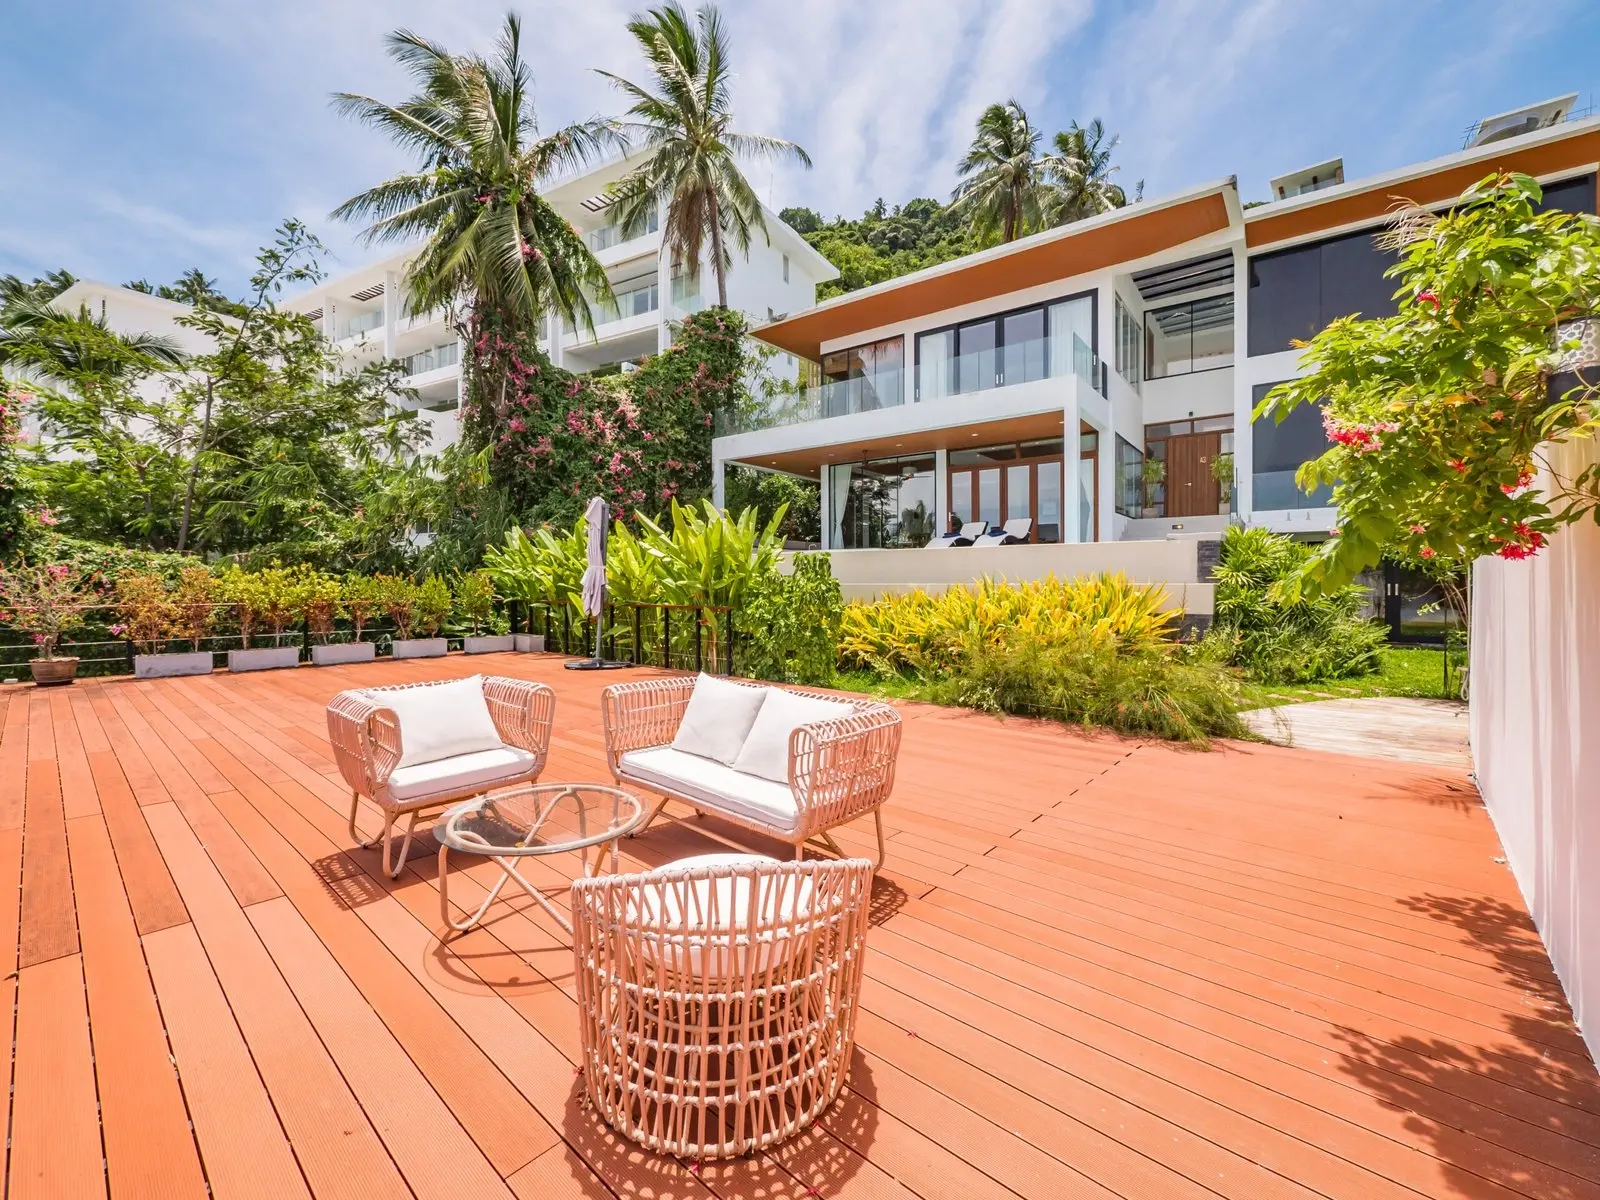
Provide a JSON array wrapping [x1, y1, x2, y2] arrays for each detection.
[[726, 96, 1600, 570]]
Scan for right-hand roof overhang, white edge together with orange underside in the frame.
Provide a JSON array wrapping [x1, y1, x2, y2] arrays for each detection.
[[1245, 118, 1600, 246]]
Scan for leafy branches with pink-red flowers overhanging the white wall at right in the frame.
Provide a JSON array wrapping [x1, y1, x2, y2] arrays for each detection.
[[1256, 174, 1600, 594]]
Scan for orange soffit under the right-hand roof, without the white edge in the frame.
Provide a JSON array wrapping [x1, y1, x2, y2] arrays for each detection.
[[1245, 130, 1600, 246]]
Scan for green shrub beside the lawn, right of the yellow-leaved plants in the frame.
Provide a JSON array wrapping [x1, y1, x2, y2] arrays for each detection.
[[1206, 526, 1386, 683]]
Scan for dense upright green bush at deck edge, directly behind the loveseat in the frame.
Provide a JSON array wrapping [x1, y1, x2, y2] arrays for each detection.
[[736, 554, 845, 688]]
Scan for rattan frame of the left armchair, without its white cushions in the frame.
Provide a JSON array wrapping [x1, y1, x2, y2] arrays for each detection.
[[328, 675, 555, 878]]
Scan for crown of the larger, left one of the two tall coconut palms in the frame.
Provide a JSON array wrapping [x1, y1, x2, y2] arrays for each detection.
[[333, 13, 619, 339]]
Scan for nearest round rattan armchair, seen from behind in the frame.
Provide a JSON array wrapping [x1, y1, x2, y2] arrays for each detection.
[[571, 854, 872, 1158]]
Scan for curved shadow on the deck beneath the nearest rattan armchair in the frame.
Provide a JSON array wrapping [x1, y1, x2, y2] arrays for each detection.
[[562, 1051, 878, 1200]]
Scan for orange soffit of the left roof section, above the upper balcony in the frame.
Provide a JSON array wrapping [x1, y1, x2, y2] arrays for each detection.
[[755, 190, 1229, 360]]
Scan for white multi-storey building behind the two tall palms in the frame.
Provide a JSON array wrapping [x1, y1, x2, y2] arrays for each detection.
[[285, 152, 838, 450]]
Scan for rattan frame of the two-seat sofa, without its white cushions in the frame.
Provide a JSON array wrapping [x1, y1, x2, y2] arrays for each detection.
[[600, 677, 901, 866]]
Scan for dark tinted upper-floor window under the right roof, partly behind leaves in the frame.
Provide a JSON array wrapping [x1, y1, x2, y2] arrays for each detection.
[[1250, 174, 1595, 355]]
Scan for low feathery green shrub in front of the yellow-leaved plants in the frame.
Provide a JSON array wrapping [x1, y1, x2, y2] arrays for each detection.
[[923, 629, 1246, 746]]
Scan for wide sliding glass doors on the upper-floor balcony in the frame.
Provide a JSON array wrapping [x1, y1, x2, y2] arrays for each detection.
[[917, 296, 1094, 400]]
